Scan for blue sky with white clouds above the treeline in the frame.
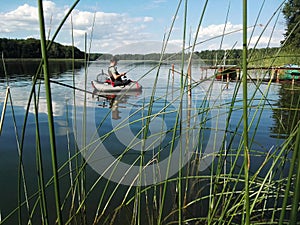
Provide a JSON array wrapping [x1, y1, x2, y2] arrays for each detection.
[[0, 0, 285, 54]]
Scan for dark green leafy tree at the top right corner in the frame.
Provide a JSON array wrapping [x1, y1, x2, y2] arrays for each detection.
[[282, 0, 300, 49]]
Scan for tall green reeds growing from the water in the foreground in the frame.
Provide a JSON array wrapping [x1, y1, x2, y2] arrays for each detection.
[[0, 0, 300, 224]]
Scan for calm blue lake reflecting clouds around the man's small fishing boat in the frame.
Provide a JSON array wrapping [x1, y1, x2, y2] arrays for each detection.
[[0, 61, 300, 224]]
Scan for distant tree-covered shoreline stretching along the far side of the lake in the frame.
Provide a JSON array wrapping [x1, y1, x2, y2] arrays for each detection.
[[0, 38, 300, 65]]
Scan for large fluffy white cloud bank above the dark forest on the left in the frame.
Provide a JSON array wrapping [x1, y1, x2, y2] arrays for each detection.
[[0, 1, 153, 52]]
